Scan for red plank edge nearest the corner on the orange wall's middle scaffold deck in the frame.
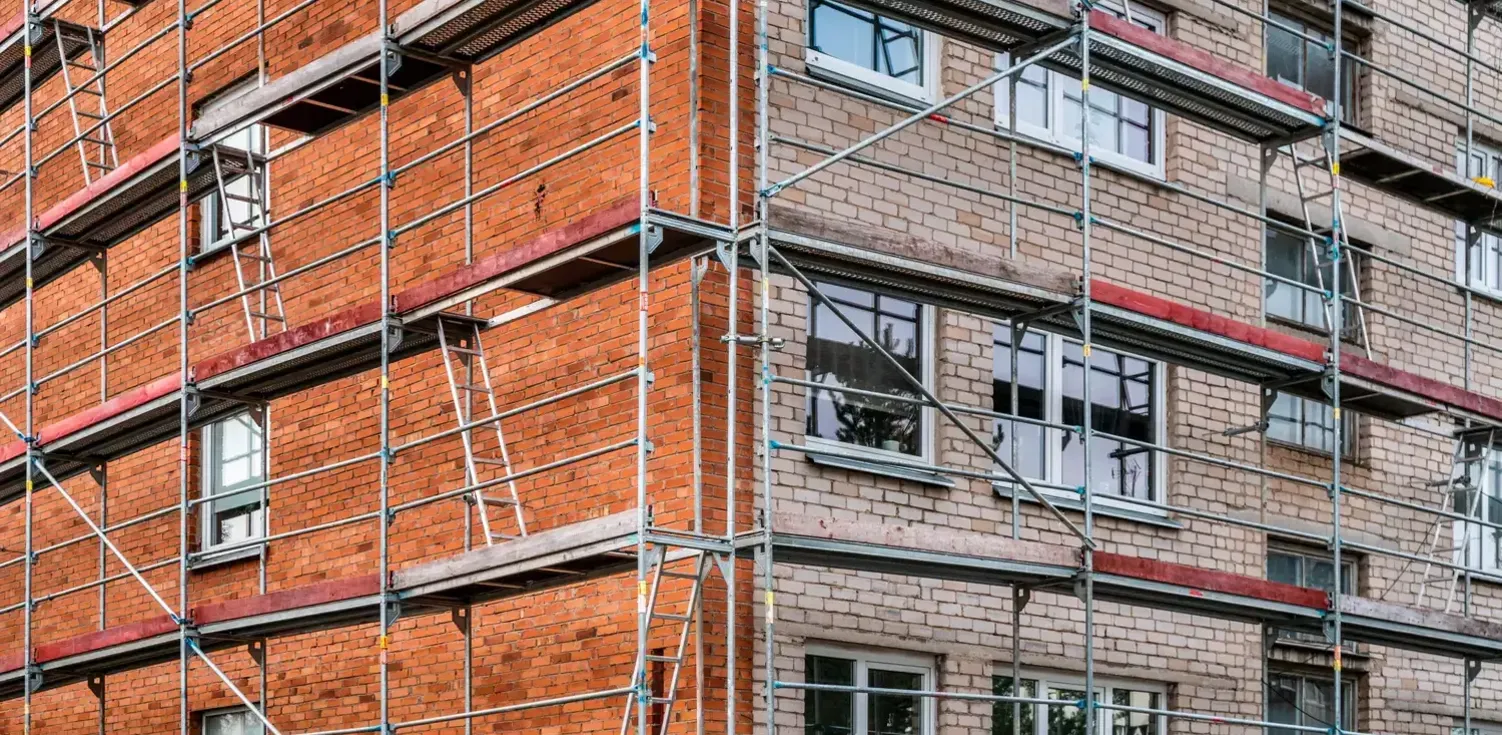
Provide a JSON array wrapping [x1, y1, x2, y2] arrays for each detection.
[[391, 197, 641, 313]]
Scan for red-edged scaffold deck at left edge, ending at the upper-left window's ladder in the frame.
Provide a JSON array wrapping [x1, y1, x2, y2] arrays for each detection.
[[0, 135, 249, 308]]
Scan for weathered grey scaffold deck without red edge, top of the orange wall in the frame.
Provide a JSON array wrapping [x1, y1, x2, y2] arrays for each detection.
[[188, 0, 615, 143]]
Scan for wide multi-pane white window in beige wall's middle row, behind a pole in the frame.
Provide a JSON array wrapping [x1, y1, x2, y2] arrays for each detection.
[[991, 323, 1164, 510]]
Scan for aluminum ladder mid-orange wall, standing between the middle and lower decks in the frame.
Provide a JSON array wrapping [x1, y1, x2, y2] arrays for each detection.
[[439, 319, 527, 546]]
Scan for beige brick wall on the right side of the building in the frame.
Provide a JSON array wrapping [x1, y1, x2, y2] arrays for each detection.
[[756, 0, 1502, 735]]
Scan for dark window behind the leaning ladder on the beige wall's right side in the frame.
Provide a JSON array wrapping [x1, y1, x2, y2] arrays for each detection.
[[1263, 227, 1361, 338]]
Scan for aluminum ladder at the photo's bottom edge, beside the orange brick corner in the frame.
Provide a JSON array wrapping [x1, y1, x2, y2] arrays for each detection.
[[620, 546, 713, 735]]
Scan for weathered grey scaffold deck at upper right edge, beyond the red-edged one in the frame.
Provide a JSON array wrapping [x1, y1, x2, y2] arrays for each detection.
[[1340, 128, 1502, 230]]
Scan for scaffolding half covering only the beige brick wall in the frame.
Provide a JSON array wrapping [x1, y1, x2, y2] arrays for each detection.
[[740, 0, 1502, 732]]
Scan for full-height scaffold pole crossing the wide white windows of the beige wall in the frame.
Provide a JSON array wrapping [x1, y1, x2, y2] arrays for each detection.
[[1075, 0, 1099, 732]]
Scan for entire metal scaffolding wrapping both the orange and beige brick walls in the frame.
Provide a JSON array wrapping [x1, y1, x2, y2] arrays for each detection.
[[0, 0, 1502, 721]]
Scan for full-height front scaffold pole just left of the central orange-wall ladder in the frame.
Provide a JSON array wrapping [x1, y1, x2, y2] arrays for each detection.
[[376, 0, 397, 733]]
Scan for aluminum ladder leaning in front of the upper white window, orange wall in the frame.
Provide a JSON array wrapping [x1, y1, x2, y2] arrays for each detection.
[[209, 146, 287, 341]]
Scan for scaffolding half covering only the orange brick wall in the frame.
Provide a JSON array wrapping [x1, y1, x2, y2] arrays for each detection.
[[0, 0, 740, 735]]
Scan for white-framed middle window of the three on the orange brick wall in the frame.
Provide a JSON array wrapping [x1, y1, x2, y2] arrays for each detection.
[[203, 413, 266, 549]]
